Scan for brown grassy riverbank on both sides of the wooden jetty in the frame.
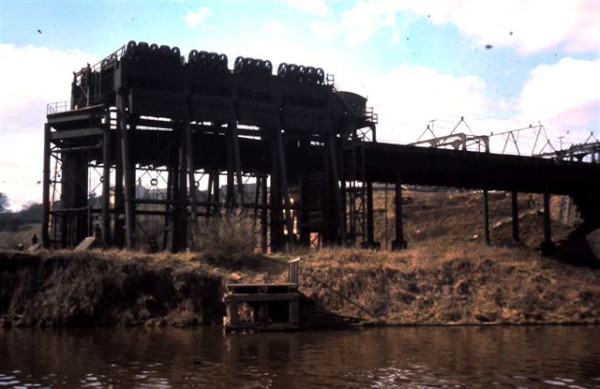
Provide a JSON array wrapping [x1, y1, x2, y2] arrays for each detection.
[[0, 242, 600, 327]]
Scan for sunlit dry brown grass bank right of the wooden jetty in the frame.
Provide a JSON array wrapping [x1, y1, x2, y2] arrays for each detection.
[[301, 243, 600, 324]]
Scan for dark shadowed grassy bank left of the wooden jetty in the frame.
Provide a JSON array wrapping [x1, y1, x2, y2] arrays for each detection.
[[0, 251, 229, 326]]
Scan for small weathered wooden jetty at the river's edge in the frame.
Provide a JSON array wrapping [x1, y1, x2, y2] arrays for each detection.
[[223, 258, 300, 331]]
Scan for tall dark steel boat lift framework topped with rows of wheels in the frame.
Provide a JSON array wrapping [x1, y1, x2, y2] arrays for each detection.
[[42, 41, 377, 251]]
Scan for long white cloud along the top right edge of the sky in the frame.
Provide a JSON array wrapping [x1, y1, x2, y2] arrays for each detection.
[[342, 0, 600, 54]]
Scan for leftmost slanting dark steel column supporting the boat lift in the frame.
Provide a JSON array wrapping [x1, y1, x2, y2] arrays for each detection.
[[117, 93, 135, 250]]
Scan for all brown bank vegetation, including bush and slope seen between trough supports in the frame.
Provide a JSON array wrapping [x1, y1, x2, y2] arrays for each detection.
[[0, 191, 600, 327]]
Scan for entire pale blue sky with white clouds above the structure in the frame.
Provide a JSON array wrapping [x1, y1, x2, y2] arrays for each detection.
[[0, 0, 600, 210]]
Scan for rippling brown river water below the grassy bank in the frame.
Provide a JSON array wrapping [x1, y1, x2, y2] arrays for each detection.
[[0, 326, 600, 389]]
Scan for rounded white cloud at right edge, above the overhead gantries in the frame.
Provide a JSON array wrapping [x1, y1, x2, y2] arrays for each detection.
[[519, 58, 600, 128]]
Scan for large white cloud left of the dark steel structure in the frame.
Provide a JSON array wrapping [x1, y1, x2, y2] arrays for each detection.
[[0, 44, 95, 210]]
